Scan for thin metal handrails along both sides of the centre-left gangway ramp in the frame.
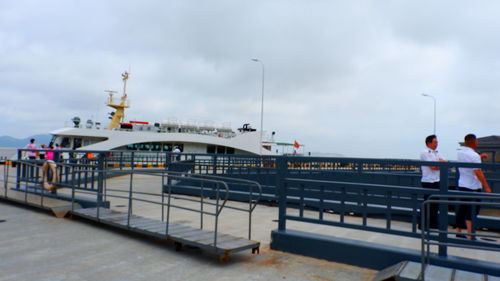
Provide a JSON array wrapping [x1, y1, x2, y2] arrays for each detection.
[[70, 167, 262, 244]]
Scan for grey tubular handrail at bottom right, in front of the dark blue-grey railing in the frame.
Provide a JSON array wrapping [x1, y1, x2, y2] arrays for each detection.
[[420, 194, 500, 281]]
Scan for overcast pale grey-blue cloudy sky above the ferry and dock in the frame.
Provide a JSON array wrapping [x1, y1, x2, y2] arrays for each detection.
[[0, 0, 500, 159]]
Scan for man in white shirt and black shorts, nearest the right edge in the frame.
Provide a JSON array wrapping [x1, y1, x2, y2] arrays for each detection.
[[456, 134, 491, 239]]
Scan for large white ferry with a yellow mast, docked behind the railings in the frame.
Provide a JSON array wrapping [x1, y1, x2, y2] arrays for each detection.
[[51, 72, 300, 155]]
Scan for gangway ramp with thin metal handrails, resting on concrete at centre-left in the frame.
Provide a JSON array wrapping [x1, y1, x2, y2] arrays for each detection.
[[72, 169, 262, 262]]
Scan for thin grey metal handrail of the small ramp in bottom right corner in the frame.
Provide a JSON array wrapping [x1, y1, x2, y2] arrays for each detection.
[[420, 194, 500, 281]]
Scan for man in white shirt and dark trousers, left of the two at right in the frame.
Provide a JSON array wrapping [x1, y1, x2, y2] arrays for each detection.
[[420, 135, 446, 228]]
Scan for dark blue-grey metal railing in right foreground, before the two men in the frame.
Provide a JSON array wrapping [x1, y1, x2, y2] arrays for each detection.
[[276, 157, 500, 274]]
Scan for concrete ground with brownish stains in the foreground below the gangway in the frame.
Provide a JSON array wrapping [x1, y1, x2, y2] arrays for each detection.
[[0, 201, 375, 281]]
